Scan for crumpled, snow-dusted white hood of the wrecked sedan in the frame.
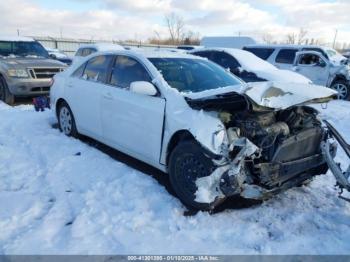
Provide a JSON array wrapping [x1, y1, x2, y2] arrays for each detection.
[[183, 82, 337, 110]]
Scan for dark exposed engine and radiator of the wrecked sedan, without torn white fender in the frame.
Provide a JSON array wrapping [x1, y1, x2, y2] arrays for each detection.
[[219, 106, 334, 189]]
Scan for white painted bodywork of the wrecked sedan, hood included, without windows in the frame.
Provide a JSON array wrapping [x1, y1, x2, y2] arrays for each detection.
[[50, 50, 335, 171]]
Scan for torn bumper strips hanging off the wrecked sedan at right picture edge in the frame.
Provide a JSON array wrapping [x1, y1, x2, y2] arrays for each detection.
[[321, 120, 350, 191]]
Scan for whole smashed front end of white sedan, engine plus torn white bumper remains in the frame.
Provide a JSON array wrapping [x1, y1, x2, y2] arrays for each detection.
[[189, 94, 346, 205]]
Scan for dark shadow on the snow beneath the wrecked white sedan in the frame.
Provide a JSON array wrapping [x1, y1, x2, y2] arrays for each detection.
[[52, 123, 261, 216]]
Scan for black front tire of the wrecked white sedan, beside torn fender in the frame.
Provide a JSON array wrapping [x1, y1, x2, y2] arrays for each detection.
[[169, 140, 220, 210]]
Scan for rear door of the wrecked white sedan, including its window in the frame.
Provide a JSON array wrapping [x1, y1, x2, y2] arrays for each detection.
[[66, 55, 113, 139]]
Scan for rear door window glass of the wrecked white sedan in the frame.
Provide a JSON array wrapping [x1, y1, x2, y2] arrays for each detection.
[[83, 55, 112, 83]]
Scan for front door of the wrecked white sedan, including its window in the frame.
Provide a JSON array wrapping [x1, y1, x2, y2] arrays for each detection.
[[101, 55, 165, 164]]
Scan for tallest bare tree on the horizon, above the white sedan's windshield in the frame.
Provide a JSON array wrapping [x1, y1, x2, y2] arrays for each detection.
[[165, 13, 185, 45]]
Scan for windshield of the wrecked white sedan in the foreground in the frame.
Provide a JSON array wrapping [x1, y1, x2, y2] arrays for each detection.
[[149, 58, 242, 93]]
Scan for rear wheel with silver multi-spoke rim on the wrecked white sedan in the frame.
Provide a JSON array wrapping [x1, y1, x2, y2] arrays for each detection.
[[57, 101, 78, 137]]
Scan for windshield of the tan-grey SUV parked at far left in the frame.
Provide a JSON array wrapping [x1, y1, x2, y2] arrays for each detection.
[[0, 41, 48, 58]]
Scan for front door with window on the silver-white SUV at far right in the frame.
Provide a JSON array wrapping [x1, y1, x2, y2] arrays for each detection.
[[294, 51, 329, 86]]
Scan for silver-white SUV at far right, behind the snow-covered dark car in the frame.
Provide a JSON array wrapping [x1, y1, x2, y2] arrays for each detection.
[[243, 45, 350, 100]]
